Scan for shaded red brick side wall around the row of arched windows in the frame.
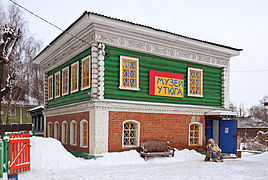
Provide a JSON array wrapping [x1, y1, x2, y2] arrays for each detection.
[[46, 112, 89, 153]]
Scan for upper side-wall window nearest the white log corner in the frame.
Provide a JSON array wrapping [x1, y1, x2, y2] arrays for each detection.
[[81, 56, 90, 90]]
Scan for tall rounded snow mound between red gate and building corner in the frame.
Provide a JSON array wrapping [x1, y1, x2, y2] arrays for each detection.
[[31, 137, 85, 170]]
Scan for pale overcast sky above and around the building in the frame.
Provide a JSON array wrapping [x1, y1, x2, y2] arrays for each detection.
[[0, 0, 268, 106]]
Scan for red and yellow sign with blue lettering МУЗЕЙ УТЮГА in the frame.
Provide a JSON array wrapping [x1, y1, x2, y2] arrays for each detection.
[[149, 70, 184, 98]]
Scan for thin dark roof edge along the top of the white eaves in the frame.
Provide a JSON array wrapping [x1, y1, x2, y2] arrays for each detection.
[[34, 11, 243, 60]]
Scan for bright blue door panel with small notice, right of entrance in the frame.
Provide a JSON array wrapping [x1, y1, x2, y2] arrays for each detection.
[[219, 120, 236, 153]]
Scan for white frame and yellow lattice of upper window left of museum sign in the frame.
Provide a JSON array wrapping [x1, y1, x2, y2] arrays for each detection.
[[119, 56, 140, 90]]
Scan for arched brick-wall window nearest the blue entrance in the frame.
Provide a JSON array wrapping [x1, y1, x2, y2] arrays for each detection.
[[189, 122, 202, 146]]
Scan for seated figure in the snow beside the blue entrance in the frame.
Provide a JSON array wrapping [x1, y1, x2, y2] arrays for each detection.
[[205, 138, 223, 162]]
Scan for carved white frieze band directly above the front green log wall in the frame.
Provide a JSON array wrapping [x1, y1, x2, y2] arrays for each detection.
[[95, 31, 229, 67]]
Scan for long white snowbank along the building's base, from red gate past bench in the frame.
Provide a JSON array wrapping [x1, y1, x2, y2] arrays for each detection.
[[31, 137, 204, 170]]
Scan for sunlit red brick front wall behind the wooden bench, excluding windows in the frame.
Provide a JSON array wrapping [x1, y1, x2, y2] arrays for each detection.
[[108, 111, 205, 152]]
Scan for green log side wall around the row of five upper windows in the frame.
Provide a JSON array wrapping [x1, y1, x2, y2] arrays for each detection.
[[48, 49, 91, 108]]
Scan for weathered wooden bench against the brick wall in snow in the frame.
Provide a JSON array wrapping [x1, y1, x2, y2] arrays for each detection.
[[140, 141, 175, 160]]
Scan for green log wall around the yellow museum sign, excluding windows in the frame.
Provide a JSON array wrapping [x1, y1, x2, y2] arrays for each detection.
[[104, 46, 222, 107]]
